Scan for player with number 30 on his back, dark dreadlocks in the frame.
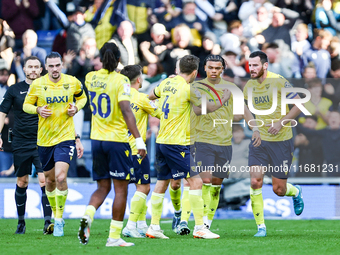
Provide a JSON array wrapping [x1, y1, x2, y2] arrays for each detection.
[[78, 43, 146, 246]]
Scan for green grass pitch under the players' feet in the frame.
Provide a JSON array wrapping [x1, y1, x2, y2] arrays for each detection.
[[0, 219, 340, 255]]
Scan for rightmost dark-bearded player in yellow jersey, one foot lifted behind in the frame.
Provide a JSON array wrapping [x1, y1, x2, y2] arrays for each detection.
[[243, 51, 304, 237]]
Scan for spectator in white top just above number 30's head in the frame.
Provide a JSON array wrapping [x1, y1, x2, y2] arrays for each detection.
[[111, 20, 140, 68]]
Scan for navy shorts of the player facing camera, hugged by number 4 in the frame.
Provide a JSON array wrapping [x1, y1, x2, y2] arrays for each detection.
[[195, 142, 233, 178]]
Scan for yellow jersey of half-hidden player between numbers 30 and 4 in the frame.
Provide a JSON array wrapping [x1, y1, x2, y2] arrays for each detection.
[[129, 88, 162, 155]]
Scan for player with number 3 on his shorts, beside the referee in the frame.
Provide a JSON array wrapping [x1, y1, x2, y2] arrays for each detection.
[[23, 52, 86, 236]]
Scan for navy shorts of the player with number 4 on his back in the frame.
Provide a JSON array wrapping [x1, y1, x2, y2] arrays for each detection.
[[155, 143, 197, 180]]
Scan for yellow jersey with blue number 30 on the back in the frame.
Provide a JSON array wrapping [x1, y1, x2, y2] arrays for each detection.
[[85, 69, 131, 143]]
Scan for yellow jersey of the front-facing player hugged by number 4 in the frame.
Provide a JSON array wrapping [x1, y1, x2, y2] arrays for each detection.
[[194, 78, 236, 146]]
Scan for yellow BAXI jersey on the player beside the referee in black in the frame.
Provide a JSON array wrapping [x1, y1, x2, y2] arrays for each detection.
[[23, 74, 87, 147]]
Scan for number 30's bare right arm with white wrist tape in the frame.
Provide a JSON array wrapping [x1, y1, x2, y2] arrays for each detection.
[[119, 101, 146, 159]]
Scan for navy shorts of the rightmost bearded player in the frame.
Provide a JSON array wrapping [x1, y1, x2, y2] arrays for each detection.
[[248, 139, 294, 179]]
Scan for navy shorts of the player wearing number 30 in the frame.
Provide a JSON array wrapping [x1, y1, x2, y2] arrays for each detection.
[[91, 140, 133, 181]]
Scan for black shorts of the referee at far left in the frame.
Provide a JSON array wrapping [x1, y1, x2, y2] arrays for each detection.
[[13, 148, 43, 177]]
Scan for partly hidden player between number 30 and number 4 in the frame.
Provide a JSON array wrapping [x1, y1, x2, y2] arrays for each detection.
[[120, 65, 162, 238]]
